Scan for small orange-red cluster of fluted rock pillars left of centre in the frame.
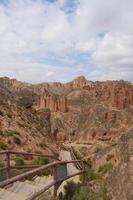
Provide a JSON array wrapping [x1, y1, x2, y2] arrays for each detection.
[[36, 94, 67, 112]]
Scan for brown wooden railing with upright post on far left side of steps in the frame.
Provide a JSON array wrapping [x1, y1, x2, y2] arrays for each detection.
[[0, 150, 59, 179]]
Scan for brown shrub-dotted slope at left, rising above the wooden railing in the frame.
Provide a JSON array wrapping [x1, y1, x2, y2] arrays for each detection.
[[0, 77, 55, 153]]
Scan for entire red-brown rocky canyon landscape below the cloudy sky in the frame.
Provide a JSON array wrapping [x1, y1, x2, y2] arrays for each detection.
[[0, 76, 133, 200]]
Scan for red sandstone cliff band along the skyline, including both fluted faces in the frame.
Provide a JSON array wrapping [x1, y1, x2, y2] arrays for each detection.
[[0, 76, 133, 112]]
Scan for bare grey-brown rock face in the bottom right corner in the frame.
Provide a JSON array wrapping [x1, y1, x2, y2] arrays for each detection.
[[107, 129, 133, 200]]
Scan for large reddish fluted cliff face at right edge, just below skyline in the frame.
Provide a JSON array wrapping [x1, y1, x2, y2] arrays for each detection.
[[91, 81, 133, 110]]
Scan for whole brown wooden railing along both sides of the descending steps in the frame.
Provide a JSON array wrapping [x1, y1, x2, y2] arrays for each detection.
[[0, 151, 85, 200]]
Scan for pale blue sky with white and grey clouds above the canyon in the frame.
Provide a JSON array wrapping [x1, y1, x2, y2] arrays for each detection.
[[0, 0, 133, 83]]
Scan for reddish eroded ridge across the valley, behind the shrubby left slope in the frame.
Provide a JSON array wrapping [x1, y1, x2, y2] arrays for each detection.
[[0, 76, 133, 146]]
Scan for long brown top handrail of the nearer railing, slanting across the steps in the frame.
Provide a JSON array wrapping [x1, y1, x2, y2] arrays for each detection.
[[0, 160, 82, 187]]
